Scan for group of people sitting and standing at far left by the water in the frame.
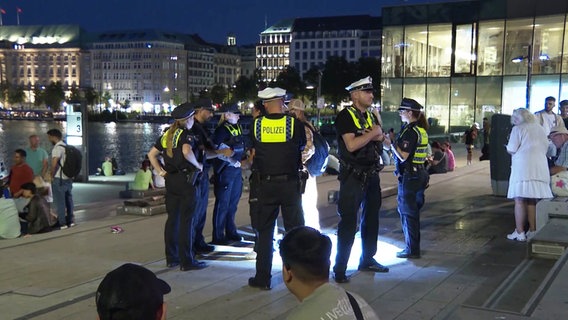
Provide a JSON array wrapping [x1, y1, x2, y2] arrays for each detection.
[[0, 129, 75, 238]]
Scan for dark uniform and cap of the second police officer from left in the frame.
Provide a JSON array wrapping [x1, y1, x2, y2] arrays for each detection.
[[191, 99, 217, 253]]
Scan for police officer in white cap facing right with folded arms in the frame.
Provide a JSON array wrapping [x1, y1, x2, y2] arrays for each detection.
[[333, 77, 389, 283]]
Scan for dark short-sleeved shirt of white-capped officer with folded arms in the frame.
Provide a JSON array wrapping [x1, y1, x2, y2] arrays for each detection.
[[335, 108, 382, 168]]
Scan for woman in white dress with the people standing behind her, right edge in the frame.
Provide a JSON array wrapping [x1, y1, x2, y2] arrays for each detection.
[[506, 97, 568, 241]]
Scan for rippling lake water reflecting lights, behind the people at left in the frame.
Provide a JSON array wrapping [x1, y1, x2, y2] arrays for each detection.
[[0, 120, 164, 174]]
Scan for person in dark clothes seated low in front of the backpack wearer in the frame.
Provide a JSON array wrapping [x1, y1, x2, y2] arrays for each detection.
[[19, 182, 51, 234]]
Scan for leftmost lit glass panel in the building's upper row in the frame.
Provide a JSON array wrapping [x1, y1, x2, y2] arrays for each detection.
[[381, 27, 403, 78]]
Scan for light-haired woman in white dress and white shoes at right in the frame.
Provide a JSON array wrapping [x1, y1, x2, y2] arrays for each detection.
[[506, 108, 552, 241]]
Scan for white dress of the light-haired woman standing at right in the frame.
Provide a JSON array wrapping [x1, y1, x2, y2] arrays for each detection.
[[507, 123, 552, 199]]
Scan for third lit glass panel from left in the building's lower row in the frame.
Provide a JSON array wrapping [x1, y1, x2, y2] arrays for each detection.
[[425, 78, 450, 134]]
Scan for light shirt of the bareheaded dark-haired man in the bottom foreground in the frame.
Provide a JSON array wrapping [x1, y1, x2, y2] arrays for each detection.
[[287, 283, 379, 320]]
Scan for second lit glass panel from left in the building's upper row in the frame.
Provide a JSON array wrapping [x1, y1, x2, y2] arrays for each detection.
[[404, 25, 428, 77]]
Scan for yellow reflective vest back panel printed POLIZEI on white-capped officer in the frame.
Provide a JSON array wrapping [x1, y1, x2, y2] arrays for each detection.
[[254, 116, 294, 143]]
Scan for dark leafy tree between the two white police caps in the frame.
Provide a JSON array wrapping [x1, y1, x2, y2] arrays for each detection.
[[321, 57, 357, 105]]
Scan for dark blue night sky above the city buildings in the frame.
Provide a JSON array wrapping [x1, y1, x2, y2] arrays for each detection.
[[0, 0, 448, 45]]
